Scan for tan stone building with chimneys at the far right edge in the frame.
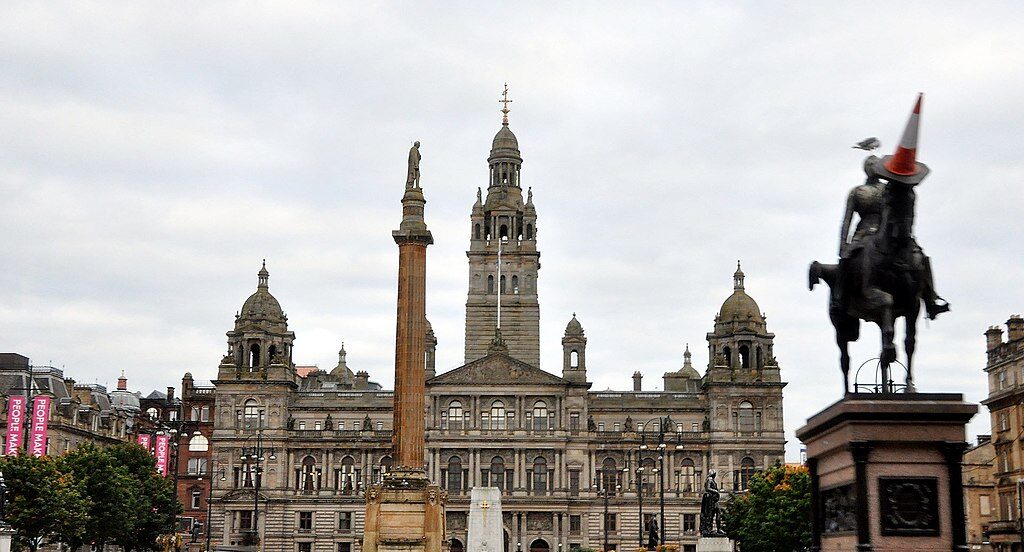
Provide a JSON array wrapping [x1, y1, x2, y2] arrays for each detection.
[[981, 315, 1024, 552]]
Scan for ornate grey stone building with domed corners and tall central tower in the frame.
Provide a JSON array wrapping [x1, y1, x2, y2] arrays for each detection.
[[210, 112, 785, 552]]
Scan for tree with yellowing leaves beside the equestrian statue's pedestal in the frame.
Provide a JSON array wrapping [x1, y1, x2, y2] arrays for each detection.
[[723, 464, 811, 552]]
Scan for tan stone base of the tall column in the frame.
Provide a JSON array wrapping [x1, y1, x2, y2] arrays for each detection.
[[362, 470, 447, 552]]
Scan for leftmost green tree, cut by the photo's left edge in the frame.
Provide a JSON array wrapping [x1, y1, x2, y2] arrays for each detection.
[[0, 455, 89, 551]]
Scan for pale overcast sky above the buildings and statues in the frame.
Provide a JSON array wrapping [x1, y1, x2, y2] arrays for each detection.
[[0, 2, 1024, 458]]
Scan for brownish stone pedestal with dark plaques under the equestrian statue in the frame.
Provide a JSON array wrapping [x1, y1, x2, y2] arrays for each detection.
[[797, 393, 978, 552]]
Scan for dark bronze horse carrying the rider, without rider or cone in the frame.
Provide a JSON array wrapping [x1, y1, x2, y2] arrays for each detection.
[[808, 180, 927, 393]]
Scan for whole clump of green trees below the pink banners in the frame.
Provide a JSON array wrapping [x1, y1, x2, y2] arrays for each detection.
[[0, 443, 181, 551]]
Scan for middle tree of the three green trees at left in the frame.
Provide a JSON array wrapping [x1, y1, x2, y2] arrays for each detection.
[[59, 442, 142, 550]]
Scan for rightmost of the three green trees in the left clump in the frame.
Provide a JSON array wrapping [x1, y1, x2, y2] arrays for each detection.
[[106, 443, 181, 550]]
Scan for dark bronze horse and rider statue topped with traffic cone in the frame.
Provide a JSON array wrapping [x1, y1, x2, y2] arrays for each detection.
[[808, 96, 949, 393]]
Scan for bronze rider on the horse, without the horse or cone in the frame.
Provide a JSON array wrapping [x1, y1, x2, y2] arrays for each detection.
[[837, 156, 949, 320]]
